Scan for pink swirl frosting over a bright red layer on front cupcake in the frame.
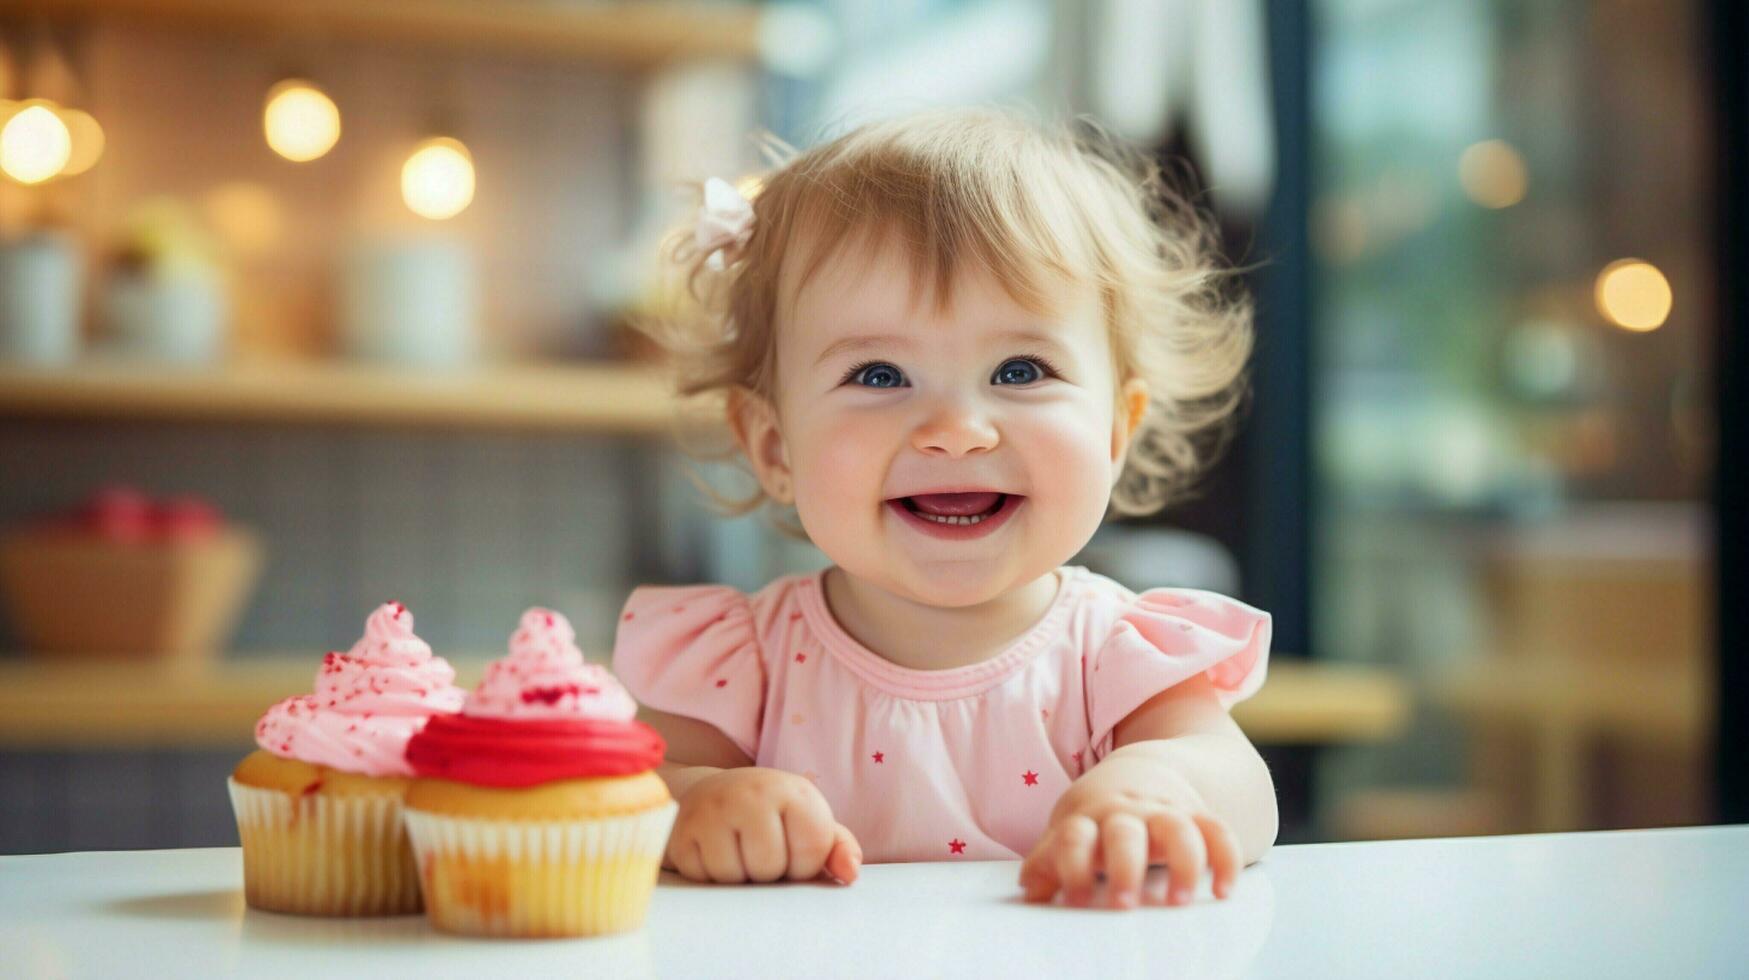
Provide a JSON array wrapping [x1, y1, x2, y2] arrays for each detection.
[[408, 607, 666, 788]]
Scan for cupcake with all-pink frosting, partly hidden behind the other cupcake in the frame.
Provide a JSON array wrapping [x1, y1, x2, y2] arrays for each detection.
[[229, 602, 467, 915]]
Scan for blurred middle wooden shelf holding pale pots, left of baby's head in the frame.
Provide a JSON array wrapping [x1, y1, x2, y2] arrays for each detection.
[[0, 362, 689, 432]]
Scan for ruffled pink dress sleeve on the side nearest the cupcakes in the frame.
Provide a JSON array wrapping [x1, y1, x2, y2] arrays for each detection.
[[614, 585, 766, 758]]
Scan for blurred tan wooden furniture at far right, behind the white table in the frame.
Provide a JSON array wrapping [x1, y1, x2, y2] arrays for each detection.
[[1331, 504, 1711, 838]]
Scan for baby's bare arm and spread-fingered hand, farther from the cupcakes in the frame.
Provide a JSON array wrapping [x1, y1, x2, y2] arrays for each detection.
[[1020, 677, 1279, 908]]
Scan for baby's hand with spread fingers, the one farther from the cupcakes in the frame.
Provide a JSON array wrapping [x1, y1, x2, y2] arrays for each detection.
[[1020, 753, 1240, 908]]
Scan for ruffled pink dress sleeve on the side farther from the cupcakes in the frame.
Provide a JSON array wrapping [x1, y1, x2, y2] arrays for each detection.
[[1086, 588, 1270, 760]]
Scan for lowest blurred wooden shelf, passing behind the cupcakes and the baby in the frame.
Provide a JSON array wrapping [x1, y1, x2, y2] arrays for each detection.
[[0, 655, 1408, 749]]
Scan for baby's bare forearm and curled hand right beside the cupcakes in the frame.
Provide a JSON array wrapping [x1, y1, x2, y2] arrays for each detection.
[[640, 711, 862, 884]]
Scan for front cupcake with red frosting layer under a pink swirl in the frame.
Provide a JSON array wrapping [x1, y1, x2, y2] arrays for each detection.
[[406, 609, 679, 936]]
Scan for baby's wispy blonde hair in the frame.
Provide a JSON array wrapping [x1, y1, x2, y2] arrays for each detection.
[[638, 109, 1252, 515]]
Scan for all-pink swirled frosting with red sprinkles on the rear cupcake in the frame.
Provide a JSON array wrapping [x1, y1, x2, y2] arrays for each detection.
[[255, 602, 465, 775]]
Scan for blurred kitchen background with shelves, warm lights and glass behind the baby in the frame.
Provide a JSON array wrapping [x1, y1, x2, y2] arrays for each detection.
[[0, 0, 1749, 852]]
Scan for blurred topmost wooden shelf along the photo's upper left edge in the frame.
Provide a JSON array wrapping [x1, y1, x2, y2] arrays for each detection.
[[0, 0, 761, 68]]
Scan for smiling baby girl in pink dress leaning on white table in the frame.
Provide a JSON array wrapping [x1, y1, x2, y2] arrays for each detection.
[[614, 110, 1277, 908]]
